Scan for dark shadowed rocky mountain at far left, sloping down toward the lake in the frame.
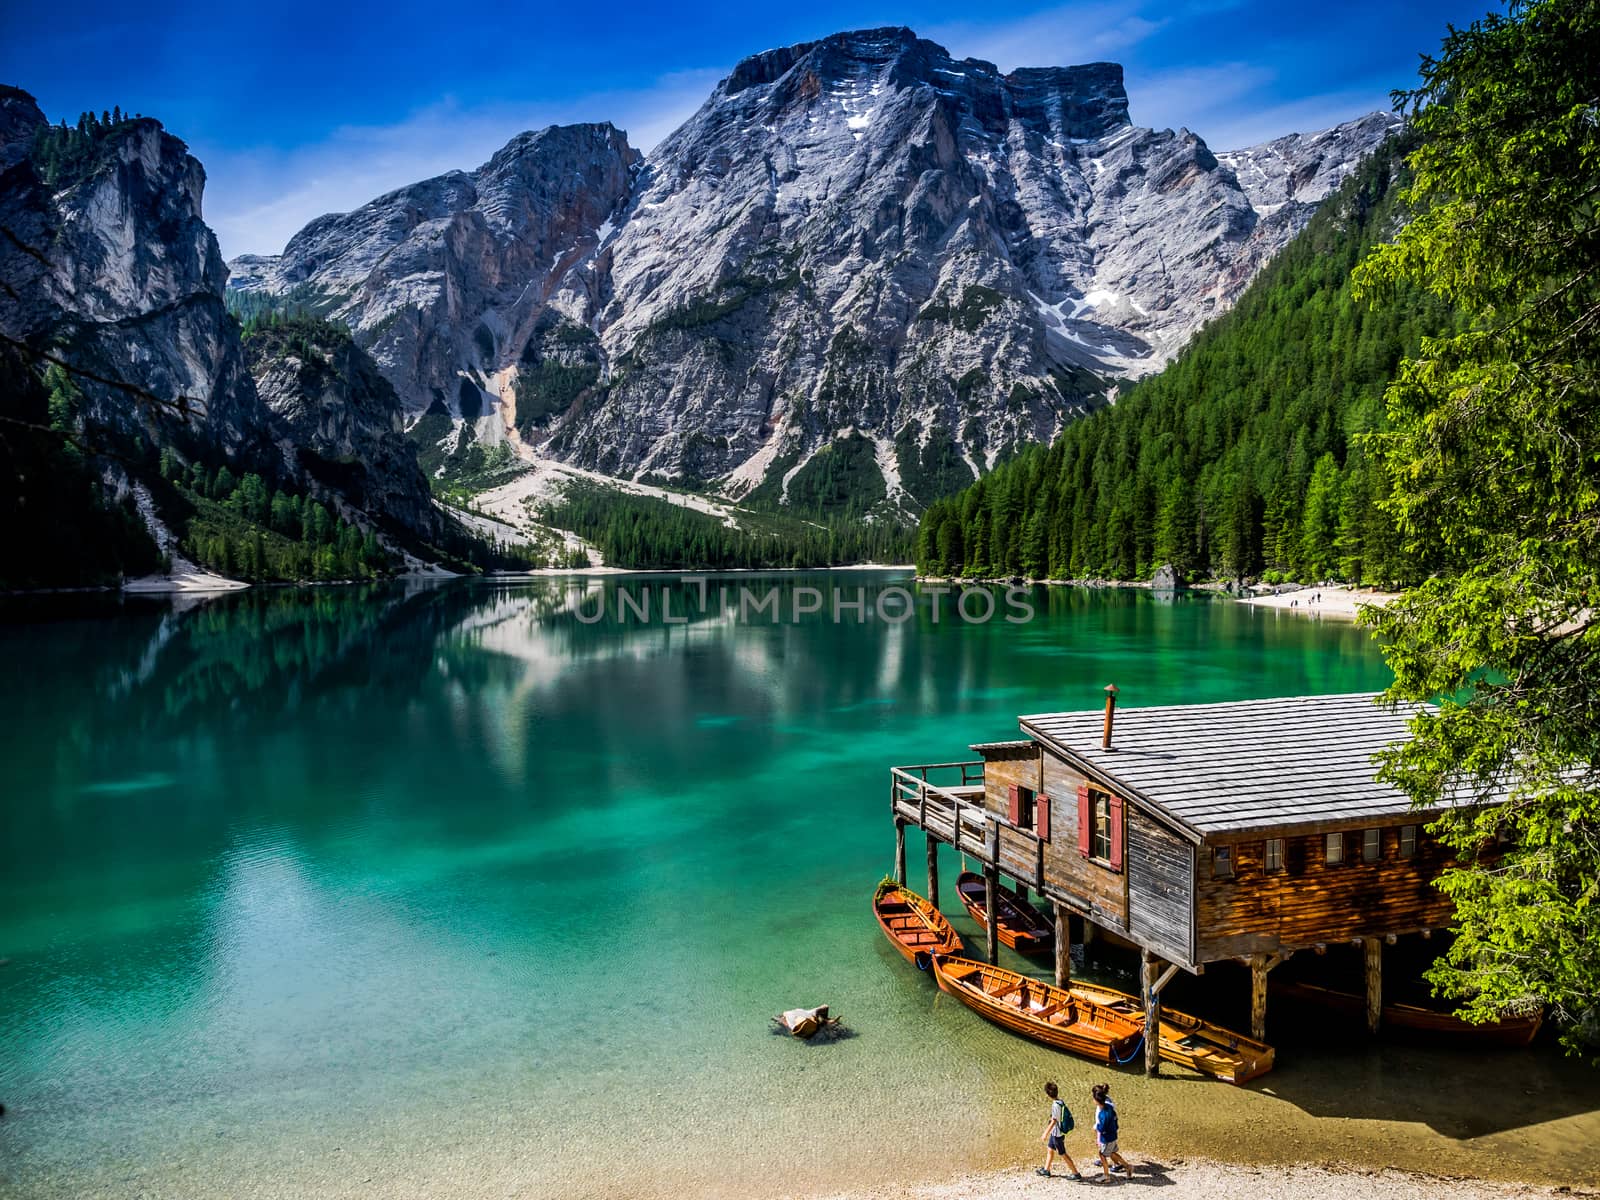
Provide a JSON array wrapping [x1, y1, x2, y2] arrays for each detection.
[[0, 88, 446, 563]]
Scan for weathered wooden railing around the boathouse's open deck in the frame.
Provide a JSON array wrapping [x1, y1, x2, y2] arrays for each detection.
[[890, 762, 1045, 888]]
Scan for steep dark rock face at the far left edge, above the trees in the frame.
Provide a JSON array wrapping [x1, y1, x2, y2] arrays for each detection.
[[0, 90, 269, 458]]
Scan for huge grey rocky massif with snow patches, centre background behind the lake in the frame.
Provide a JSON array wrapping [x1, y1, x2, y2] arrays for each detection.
[[232, 29, 1394, 509]]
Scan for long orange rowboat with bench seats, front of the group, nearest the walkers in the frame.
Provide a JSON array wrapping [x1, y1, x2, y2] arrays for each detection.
[[933, 954, 1144, 1066]]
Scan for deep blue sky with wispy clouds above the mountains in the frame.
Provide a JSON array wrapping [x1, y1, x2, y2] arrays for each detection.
[[0, 0, 1491, 256]]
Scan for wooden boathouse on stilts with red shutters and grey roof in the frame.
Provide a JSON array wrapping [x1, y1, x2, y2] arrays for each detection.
[[890, 686, 1451, 1074]]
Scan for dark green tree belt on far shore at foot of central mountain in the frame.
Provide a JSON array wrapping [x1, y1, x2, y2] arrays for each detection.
[[539, 485, 909, 570]]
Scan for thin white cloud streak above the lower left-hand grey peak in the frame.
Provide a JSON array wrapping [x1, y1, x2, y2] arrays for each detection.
[[201, 70, 725, 258]]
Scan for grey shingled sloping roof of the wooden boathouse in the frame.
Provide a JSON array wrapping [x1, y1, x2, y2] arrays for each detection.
[[1019, 693, 1440, 837]]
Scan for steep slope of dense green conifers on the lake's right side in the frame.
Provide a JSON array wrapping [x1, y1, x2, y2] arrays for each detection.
[[917, 139, 1453, 584]]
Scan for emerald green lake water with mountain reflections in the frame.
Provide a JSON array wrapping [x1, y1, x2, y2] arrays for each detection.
[[0, 573, 1600, 1197]]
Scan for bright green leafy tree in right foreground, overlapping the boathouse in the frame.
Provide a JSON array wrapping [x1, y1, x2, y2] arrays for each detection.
[[1357, 0, 1600, 1053]]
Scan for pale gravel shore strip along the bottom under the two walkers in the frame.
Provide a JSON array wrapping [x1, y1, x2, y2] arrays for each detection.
[[811, 1147, 1597, 1200]]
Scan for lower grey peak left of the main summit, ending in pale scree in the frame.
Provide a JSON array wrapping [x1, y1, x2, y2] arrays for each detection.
[[232, 125, 638, 438]]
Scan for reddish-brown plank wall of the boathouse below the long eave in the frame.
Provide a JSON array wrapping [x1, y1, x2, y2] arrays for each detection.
[[1195, 818, 1451, 962]]
